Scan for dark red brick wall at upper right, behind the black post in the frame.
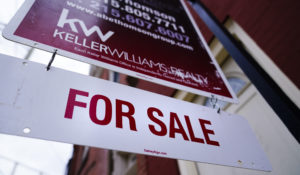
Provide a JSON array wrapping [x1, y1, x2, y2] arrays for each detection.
[[190, 0, 300, 88]]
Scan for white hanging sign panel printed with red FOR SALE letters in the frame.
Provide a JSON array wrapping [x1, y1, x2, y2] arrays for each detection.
[[0, 55, 271, 171]]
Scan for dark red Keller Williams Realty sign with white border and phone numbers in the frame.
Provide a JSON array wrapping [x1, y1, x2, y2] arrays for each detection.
[[4, 0, 237, 102]]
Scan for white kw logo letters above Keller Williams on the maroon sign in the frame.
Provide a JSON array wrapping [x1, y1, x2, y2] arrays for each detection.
[[57, 8, 114, 42]]
